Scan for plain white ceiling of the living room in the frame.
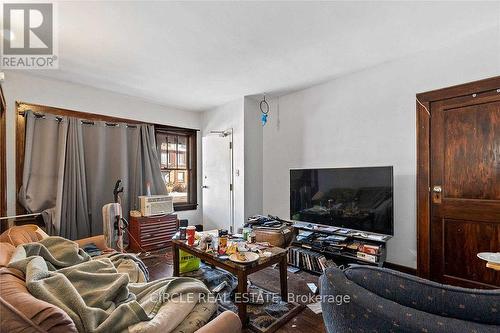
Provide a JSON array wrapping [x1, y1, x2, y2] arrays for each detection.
[[20, 1, 500, 111]]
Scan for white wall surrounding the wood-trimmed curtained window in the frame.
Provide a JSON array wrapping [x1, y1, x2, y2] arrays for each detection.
[[3, 70, 202, 224]]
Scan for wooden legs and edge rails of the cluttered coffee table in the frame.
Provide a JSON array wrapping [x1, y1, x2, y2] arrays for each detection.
[[172, 240, 288, 326]]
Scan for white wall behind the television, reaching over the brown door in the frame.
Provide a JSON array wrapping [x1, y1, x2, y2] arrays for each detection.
[[263, 29, 500, 267]]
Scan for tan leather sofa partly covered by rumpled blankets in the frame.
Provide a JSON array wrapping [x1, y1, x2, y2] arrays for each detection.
[[0, 225, 241, 333]]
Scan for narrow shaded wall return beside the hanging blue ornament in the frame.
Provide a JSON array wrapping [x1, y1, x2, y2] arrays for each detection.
[[244, 97, 263, 218]]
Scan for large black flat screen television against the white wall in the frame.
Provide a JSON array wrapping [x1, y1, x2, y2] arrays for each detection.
[[290, 166, 394, 235]]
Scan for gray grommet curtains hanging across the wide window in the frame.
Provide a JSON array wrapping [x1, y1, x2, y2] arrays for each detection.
[[19, 112, 167, 239]]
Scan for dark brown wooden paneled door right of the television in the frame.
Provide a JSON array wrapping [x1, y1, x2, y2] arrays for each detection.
[[419, 78, 500, 288]]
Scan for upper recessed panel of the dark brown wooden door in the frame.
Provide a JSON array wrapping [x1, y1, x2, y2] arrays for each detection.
[[444, 101, 500, 200]]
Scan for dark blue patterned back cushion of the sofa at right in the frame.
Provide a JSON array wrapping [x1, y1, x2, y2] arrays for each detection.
[[345, 265, 500, 325]]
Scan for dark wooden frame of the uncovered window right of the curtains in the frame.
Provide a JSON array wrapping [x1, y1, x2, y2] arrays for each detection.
[[155, 125, 198, 211]]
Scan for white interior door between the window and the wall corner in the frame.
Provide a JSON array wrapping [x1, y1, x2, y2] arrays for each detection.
[[202, 134, 233, 231]]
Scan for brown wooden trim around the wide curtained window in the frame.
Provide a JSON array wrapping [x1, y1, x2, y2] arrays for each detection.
[[16, 101, 198, 215]]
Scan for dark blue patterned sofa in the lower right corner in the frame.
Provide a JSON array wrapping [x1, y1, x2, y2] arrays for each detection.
[[320, 265, 500, 333]]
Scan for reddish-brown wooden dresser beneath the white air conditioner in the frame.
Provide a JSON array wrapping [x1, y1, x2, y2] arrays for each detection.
[[129, 214, 177, 251]]
